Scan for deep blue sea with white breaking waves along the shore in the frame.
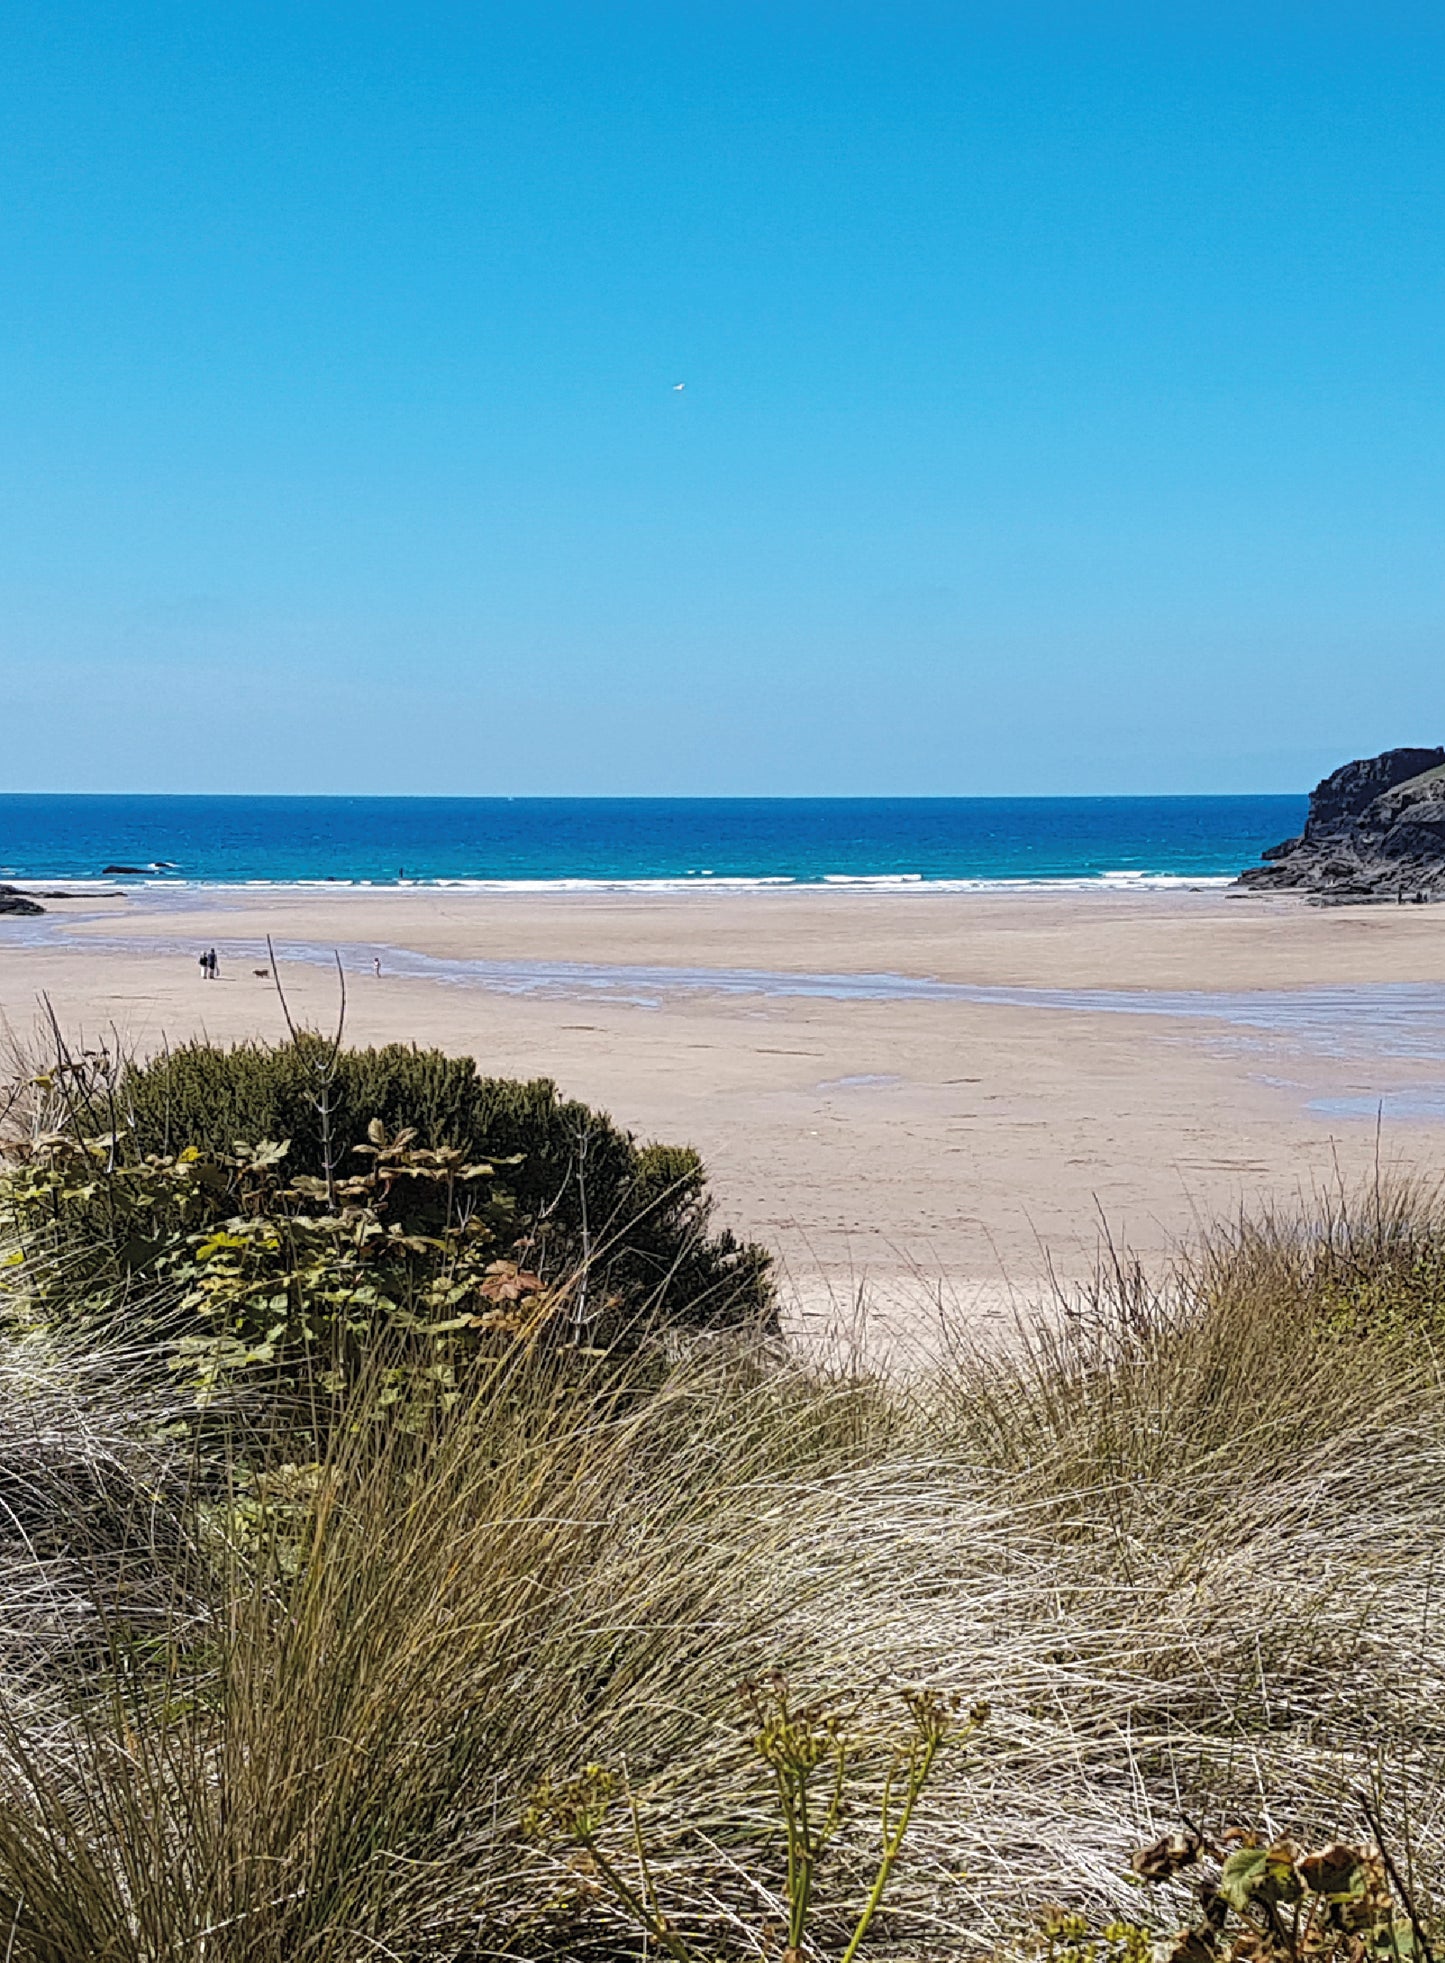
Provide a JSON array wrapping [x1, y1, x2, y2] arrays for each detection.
[[0, 795, 1306, 885]]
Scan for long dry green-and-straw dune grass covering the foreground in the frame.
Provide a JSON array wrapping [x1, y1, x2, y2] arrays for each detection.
[[0, 1194, 1445, 1963]]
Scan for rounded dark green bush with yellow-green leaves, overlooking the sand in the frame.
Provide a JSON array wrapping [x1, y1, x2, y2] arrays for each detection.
[[0, 1035, 772, 1392]]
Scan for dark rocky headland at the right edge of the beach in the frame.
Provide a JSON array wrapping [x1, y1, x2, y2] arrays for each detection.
[[1239, 750, 1445, 901]]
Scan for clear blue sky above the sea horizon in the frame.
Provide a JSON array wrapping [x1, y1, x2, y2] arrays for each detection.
[[0, 0, 1445, 795]]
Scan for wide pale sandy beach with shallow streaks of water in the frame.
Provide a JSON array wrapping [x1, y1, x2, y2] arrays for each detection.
[[0, 887, 1445, 1342]]
